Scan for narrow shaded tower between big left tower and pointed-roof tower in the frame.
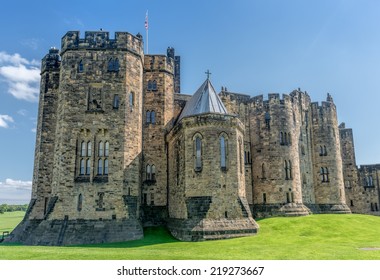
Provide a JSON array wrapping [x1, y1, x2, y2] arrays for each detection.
[[142, 52, 174, 225]]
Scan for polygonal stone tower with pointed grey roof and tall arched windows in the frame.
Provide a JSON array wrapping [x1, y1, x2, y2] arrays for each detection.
[[167, 79, 258, 240]]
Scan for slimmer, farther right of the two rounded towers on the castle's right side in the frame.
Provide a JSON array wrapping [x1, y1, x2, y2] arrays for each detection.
[[311, 94, 351, 213]]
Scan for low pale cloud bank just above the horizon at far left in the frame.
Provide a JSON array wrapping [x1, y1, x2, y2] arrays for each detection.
[[0, 179, 32, 204]]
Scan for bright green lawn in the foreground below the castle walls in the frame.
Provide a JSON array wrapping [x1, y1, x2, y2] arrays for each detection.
[[0, 214, 380, 260]]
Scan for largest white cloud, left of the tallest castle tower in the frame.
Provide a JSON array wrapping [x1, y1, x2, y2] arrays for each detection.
[[0, 52, 40, 102]]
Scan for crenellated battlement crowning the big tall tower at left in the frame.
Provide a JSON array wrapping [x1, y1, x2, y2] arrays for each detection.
[[61, 31, 144, 55]]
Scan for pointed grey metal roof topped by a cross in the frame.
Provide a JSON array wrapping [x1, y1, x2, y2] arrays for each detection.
[[178, 78, 228, 120]]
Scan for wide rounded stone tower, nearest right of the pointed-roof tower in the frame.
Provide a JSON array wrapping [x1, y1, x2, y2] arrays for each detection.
[[250, 94, 309, 216]]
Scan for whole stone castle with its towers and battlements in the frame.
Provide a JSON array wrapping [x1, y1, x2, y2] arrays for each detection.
[[7, 31, 380, 245]]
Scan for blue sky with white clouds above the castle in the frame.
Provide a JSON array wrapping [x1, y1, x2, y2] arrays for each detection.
[[0, 0, 380, 203]]
